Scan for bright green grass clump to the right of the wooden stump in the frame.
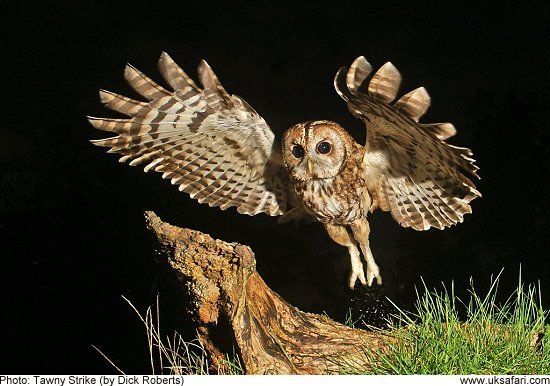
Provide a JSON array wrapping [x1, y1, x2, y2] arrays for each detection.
[[342, 274, 550, 374]]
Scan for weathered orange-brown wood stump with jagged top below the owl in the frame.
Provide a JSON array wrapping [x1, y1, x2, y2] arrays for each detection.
[[145, 212, 391, 374]]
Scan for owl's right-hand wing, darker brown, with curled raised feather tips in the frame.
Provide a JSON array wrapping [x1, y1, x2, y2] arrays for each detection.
[[334, 57, 481, 230]]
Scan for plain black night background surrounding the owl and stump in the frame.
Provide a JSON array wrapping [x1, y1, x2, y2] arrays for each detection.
[[0, 0, 550, 373]]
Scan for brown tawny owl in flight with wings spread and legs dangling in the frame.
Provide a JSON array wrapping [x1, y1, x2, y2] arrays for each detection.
[[88, 53, 481, 288]]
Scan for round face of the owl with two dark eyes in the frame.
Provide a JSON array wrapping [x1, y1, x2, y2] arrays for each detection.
[[282, 121, 349, 181]]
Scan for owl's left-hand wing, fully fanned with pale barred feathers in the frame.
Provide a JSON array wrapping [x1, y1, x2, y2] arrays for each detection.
[[88, 53, 290, 216]]
